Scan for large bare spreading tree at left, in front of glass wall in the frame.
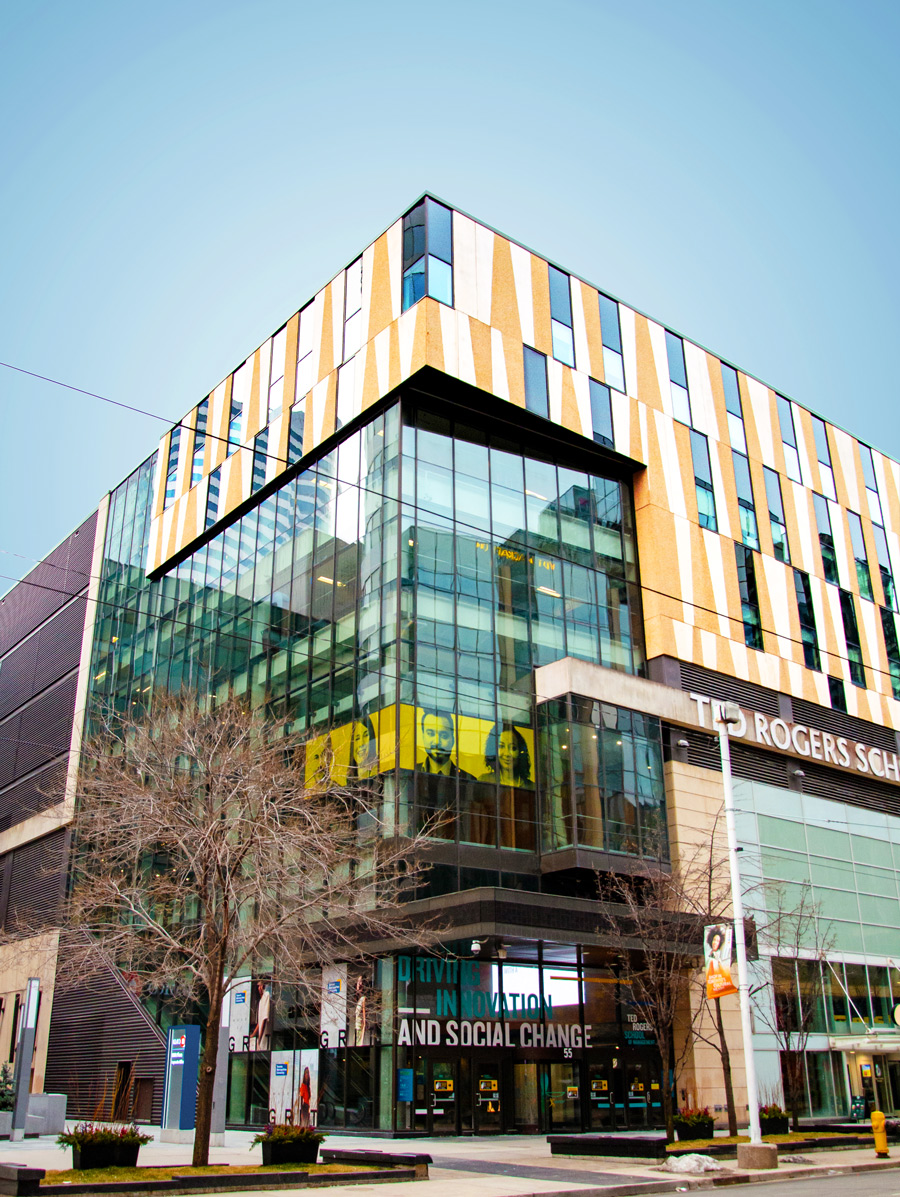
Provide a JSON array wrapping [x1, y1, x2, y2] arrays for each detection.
[[49, 693, 430, 1165]]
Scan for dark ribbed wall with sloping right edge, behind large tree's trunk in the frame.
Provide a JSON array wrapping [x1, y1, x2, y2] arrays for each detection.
[[44, 957, 165, 1125]]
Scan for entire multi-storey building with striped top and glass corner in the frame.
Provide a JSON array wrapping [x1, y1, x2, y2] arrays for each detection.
[[0, 198, 900, 1132]]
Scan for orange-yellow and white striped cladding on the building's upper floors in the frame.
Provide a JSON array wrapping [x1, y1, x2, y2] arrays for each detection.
[[144, 197, 900, 727]]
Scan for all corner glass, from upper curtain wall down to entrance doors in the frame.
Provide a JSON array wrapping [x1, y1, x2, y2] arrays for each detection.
[[92, 397, 667, 1132]]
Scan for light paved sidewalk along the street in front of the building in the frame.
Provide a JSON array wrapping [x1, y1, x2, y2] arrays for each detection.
[[0, 1129, 900, 1197]]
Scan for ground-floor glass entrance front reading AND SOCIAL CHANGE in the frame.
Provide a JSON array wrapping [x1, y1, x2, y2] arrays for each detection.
[[221, 942, 663, 1135]]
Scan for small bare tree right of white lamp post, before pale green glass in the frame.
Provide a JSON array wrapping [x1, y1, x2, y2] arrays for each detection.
[[750, 883, 834, 1130]]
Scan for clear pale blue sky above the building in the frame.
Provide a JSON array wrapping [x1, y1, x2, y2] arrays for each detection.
[[0, 0, 900, 591]]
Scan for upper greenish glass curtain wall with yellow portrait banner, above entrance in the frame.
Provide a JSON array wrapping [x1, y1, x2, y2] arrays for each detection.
[[92, 392, 662, 885]]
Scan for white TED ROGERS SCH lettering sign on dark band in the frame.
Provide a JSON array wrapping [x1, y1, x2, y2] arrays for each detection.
[[688, 693, 900, 784]]
